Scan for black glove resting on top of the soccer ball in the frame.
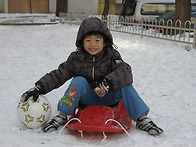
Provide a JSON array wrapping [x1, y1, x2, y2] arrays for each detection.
[[20, 84, 44, 102]]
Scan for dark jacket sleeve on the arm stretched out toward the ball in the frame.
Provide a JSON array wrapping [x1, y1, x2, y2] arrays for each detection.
[[35, 53, 74, 94]]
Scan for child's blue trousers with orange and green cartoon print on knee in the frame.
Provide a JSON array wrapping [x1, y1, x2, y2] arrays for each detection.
[[57, 76, 149, 121]]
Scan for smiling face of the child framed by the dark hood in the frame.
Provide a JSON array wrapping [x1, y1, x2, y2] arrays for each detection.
[[83, 35, 105, 55]]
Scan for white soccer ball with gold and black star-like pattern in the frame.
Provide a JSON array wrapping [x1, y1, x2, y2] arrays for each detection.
[[17, 95, 51, 129]]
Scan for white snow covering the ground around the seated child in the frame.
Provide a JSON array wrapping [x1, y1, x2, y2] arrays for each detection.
[[0, 14, 196, 147]]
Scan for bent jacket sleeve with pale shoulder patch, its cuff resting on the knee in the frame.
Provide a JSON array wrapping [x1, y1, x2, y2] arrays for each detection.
[[105, 51, 133, 90]]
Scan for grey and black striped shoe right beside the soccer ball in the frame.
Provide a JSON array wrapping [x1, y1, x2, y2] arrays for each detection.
[[42, 112, 67, 132]]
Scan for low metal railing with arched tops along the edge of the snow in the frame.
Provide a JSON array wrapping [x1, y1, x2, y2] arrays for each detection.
[[60, 13, 196, 48]]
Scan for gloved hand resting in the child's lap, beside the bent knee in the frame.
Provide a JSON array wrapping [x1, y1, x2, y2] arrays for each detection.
[[94, 79, 110, 97]]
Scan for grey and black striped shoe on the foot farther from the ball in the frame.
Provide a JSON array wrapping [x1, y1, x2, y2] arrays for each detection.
[[136, 115, 163, 136]]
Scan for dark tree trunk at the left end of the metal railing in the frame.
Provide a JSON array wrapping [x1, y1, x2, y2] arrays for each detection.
[[56, 0, 67, 17]]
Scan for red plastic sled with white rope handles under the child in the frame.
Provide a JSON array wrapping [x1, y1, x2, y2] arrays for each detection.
[[66, 100, 132, 132]]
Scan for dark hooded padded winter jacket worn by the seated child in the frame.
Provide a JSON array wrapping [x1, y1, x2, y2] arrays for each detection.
[[35, 18, 133, 94]]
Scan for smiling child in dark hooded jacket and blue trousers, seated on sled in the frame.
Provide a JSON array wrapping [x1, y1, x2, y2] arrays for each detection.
[[21, 18, 163, 135]]
